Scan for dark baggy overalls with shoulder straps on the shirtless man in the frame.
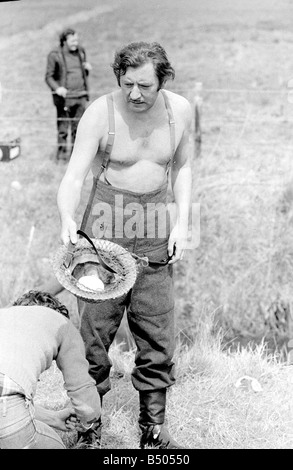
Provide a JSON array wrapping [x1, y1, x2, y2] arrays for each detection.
[[79, 91, 175, 395]]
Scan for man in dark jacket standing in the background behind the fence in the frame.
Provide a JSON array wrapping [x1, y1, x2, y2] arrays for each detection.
[[45, 28, 92, 160]]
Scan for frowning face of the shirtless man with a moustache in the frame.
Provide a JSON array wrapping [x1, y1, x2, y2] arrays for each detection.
[[120, 62, 159, 113]]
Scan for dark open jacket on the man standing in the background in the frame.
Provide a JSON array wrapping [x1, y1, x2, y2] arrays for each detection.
[[45, 46, 89, 100]]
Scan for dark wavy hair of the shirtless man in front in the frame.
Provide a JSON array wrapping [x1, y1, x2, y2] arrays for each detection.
[[111, 41, 175, 89]]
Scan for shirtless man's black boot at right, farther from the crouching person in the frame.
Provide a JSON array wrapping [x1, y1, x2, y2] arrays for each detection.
[[139, 389, 183, 449]]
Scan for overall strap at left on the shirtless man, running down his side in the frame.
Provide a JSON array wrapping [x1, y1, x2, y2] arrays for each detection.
[[80, 93, 115, 230]]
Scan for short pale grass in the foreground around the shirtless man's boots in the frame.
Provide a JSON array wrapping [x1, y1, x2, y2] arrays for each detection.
[[36, 324, 293, 449]]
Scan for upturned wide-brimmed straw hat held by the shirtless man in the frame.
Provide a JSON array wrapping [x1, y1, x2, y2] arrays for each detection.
[[52, 239, 137, 302]]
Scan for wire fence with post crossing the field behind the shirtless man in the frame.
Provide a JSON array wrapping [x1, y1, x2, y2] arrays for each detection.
[[0, 86, 293, 156]]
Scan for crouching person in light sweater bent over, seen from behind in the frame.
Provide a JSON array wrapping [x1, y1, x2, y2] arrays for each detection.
[[0, 291, 101, 449]]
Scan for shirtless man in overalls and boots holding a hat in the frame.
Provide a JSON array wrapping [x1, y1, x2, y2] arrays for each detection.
[[58, 42, 192, 448]]
